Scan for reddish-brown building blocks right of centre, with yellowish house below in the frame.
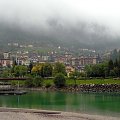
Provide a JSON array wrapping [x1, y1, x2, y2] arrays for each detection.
[[55, 53, 101, 73]]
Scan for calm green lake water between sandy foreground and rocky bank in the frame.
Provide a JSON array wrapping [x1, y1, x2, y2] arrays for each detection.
[[0, 91, 120, 116]]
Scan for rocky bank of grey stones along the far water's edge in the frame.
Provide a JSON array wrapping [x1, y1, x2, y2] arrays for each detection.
[[25, 84, 120, 93]]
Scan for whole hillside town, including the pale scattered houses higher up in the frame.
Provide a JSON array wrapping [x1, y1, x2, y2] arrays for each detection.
[[0, 43, 102, 74]]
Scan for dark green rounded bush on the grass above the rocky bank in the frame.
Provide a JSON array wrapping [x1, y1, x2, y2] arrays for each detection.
[[54, 73, 66, 88]]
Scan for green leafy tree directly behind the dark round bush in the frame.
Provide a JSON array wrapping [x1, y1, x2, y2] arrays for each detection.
[[54, 62, 66, 75]]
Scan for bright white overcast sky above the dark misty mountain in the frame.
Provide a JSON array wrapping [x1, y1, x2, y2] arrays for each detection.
[[0, 0, 120, 38]]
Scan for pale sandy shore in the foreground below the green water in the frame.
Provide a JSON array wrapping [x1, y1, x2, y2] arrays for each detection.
[[0, 107, 119, 120]]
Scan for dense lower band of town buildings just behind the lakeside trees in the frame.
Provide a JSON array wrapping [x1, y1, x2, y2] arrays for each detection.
[[0, 51, 101, 73]]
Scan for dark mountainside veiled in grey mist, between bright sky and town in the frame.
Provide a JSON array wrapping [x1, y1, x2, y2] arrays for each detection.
[[0, 19, 120, 49]]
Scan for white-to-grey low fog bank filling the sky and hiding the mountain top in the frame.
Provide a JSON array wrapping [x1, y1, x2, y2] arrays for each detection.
[[0, 0, 120, 47]]
